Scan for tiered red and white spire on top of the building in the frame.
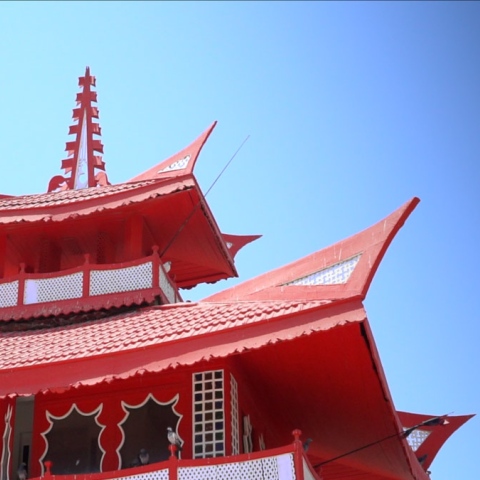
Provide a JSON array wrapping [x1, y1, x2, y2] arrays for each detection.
[[48, 67, 109, 192]]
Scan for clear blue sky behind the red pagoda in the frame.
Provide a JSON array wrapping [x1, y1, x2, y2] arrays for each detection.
[[0, 1, 480, 480]]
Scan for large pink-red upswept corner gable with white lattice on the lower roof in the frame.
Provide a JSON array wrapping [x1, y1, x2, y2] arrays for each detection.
[[204, 197, 420, 302]]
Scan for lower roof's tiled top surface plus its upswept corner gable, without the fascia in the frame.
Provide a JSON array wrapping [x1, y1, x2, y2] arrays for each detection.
[[0, 198, 419, 394]]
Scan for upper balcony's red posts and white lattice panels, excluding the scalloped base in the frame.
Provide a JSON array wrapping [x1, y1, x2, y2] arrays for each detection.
[[0, 248, 181, 311]]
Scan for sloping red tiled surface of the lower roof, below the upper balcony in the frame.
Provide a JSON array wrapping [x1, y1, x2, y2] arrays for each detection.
[[0, 301, 329, 372]]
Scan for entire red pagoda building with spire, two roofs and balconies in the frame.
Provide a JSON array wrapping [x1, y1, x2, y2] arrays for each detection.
[[0, 68, 471, 480]]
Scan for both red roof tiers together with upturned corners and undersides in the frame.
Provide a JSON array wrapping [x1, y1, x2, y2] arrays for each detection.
[[0, 67, 469, 480]]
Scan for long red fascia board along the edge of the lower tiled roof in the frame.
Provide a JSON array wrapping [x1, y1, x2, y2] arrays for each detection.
[[0, 302, 360, 396]]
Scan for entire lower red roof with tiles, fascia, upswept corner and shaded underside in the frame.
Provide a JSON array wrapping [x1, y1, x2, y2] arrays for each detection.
[[0, 199, 468, 480]]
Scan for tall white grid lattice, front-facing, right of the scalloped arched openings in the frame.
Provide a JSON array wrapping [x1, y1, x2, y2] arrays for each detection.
[[193, 370, 225, 458]]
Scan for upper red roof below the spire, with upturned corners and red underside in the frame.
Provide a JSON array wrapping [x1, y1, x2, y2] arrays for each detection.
[[0, 119, 248, 292]]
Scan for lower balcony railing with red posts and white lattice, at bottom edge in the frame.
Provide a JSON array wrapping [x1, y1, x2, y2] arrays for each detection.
[[32, 430, 320, 480]]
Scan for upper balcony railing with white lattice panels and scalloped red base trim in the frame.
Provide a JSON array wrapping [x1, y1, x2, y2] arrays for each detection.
[[0, 247, 181, 320]]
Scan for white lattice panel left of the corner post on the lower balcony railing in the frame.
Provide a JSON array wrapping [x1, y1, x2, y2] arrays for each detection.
[[178, 454, 295, 480]]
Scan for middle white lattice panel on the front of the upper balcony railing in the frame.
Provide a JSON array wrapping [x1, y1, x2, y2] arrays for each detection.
[[23, 272, 83, 305]]
